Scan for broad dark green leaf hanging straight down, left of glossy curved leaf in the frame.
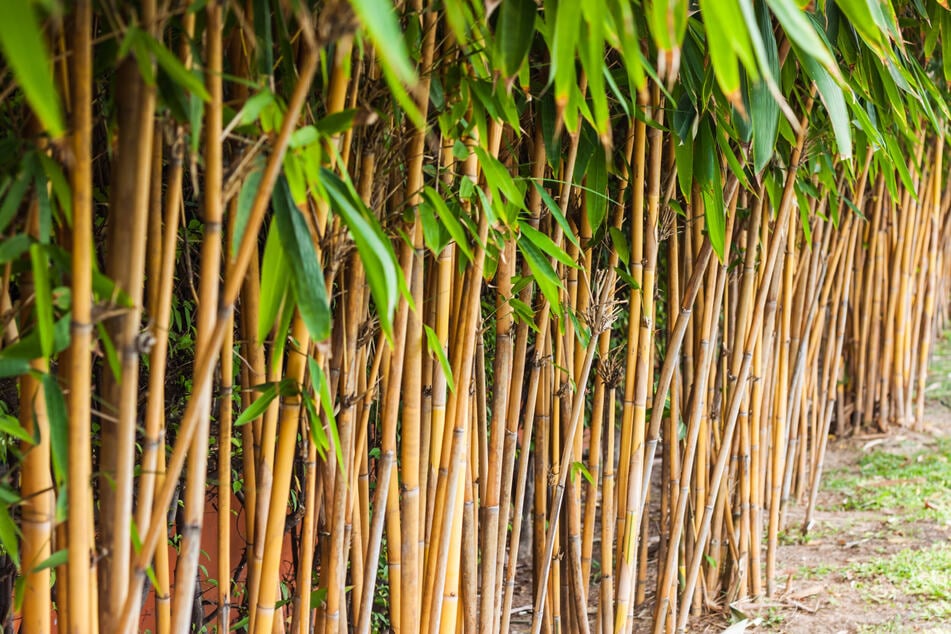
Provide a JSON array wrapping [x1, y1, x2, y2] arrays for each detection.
[[272, 176, 331, 341]]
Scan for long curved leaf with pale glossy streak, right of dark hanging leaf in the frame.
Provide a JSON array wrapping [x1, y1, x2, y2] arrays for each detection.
[[321, 169, 408, 342]]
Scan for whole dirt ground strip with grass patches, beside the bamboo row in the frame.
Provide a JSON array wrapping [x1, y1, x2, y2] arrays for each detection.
[[736, 404, 951, 634]]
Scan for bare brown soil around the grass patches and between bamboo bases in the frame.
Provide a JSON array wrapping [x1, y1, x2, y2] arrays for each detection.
[[512, 402, 951, 634]]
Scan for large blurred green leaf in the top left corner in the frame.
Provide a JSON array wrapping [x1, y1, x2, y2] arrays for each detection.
[[0, 0, 65, 137]]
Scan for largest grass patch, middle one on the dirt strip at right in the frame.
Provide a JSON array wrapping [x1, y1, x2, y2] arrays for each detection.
[[826, 438, 951, 523]]
